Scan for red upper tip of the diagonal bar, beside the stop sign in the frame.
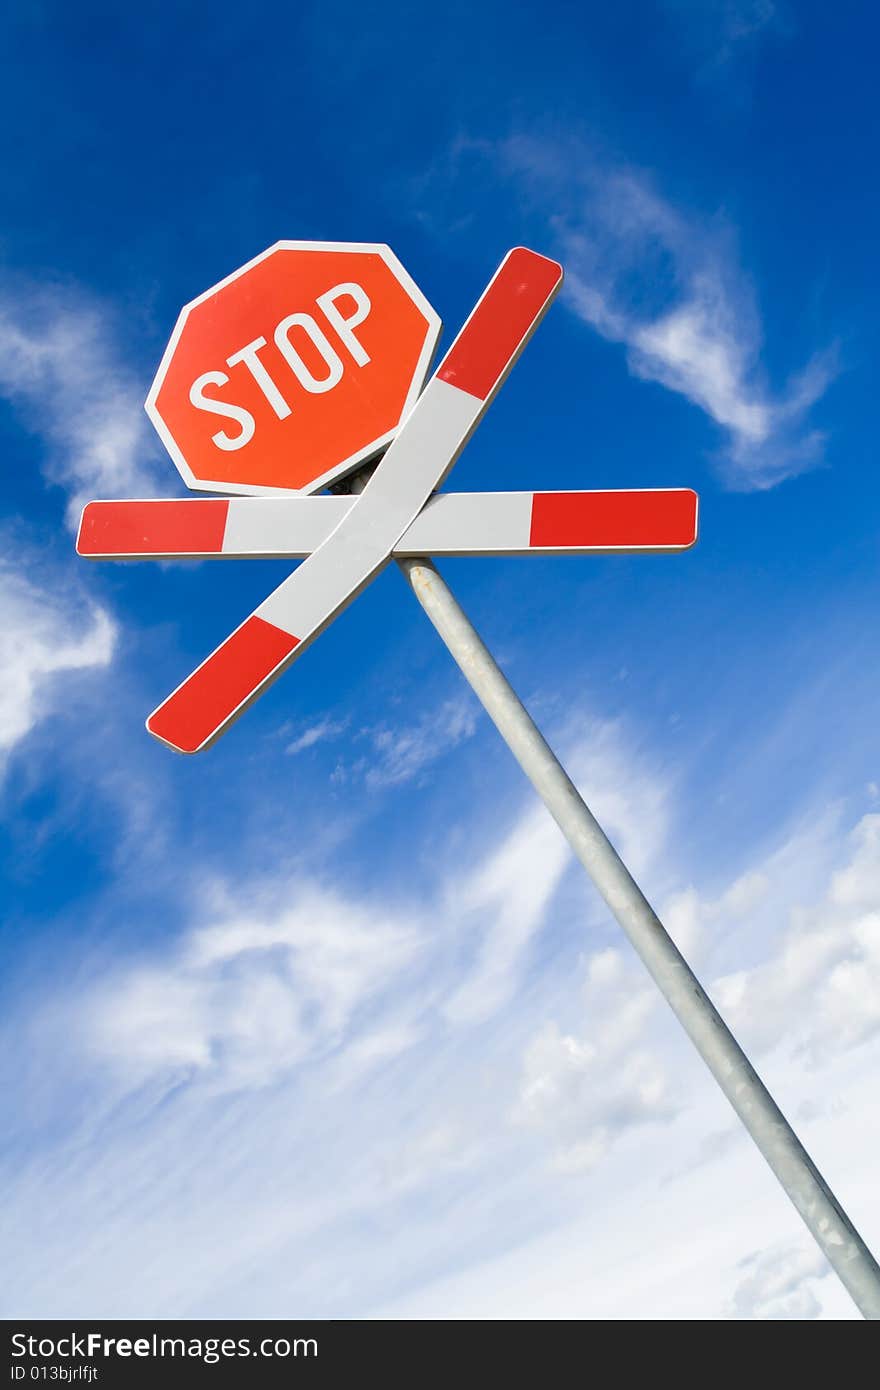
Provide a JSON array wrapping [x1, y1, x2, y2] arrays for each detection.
[[437, 246, 563, 400]]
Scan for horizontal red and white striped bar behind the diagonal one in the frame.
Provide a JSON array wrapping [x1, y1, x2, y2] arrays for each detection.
[[76, 488, 698, 560]]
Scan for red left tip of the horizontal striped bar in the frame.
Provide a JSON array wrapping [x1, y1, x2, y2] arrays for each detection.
[[76, 498, 229, 556]]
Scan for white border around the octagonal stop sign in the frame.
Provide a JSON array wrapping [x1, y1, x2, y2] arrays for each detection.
[[143, 240, 442, 498]]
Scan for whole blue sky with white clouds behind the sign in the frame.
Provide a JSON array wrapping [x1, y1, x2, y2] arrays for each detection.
[[0, 0, 880, 1318]]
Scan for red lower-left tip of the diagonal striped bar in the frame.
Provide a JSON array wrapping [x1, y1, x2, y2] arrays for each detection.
[[146, 614, 299, 753]]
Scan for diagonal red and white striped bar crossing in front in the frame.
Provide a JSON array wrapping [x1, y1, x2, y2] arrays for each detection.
[[147, 247, 562, 753]]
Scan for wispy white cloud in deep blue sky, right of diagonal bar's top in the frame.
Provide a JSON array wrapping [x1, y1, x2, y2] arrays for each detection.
[[553, 163, 834, 489]]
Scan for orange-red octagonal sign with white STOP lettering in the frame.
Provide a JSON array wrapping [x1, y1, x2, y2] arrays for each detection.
[[146, 242, 441, 493]]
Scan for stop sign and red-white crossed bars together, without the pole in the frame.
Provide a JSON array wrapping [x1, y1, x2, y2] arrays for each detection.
[[76, 242, 696, 753]]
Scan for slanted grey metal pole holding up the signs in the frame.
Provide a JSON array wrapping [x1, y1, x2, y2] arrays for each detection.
[[398, 559, 880, 1319]]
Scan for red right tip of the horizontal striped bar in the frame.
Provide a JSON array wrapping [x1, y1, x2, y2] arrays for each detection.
[[528, 488, 698, 550]]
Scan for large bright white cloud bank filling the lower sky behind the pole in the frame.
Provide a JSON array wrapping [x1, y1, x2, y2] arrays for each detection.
[[6, 724, 880, 1318]]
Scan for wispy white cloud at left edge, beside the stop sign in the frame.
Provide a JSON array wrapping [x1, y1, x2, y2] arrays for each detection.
[[0, 281, 167, 524]]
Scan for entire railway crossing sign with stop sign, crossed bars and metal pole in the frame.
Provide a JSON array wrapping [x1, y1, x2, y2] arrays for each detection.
[[76, 242, 880, 1319]]
